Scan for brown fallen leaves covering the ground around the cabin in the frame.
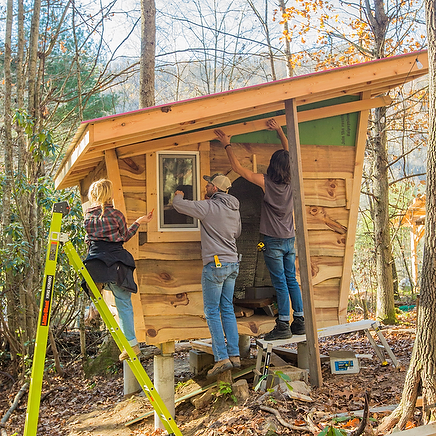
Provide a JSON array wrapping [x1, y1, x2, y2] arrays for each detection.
[[0, 315, 420, 436]]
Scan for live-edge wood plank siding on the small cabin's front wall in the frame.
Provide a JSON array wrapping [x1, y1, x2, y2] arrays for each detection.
[[115, 142, 355, 344]]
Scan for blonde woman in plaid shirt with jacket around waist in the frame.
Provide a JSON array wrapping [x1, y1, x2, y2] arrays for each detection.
[[84, 179, 153, 360]]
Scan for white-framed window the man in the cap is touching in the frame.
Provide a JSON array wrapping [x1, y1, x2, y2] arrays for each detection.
[[158, 152, 198, 229]]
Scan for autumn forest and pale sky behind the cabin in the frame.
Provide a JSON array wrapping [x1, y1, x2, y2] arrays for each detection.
[[0, 0, 434, 432]]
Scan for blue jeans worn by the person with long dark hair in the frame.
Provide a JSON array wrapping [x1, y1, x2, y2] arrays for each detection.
[[263, 235, 303, 321]]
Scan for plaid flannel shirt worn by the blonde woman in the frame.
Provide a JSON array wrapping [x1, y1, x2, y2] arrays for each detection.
[[84, 204, 139, 242]]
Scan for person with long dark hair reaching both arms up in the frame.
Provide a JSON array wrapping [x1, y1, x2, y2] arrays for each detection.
[[214, 118, 305, 341]]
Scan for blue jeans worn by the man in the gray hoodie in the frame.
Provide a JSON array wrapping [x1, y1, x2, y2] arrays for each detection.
[[201, 262, 239, 362]]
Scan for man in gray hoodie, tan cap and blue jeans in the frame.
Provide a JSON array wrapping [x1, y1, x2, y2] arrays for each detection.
[[173, 173, 241, 377]]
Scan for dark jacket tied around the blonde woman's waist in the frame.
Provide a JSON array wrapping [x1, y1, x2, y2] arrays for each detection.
[[81, 241, 138, 295]]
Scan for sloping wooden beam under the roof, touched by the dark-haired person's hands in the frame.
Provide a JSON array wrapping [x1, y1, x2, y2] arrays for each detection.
[[117, 97, 392, 158]]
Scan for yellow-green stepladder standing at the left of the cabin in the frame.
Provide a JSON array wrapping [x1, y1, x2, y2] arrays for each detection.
[[24, 201, 182, 436]]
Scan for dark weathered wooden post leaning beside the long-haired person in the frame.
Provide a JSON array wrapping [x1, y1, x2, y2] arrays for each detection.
[[285, 99, 322, 386]]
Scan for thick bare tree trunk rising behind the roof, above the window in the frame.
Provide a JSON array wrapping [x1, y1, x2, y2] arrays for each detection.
[[139, 0, 156, 108]]
